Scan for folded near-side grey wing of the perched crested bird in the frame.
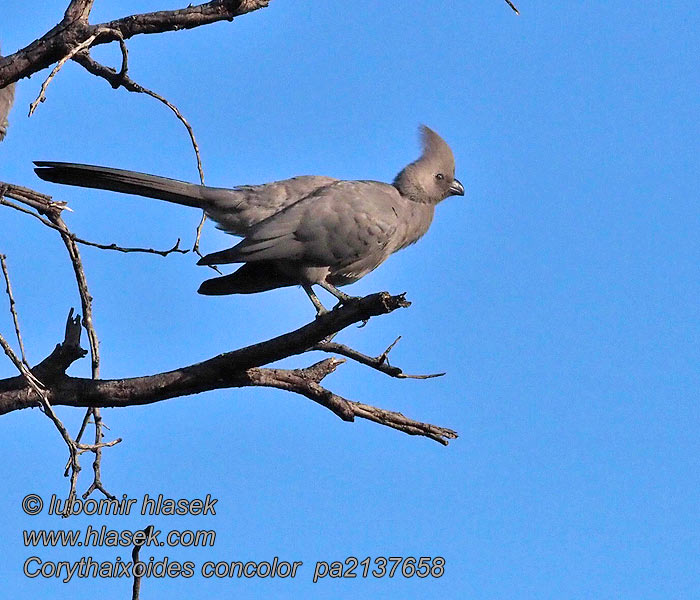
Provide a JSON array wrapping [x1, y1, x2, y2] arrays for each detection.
[[200, 181, 400, 269]]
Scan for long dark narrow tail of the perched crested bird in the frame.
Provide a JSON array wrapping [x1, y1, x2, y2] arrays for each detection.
[[34, 161, 208, 208]]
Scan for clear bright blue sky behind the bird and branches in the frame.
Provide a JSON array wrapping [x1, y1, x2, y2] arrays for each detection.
[[0, 0, 700, 600]]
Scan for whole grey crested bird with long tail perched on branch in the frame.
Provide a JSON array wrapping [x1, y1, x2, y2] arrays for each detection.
[[34, 126, 464, 315]]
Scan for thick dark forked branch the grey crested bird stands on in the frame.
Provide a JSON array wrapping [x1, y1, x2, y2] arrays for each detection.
[[0, 292, 456, 444]]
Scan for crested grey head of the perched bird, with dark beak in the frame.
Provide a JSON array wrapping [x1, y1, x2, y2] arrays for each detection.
[[394, 125, 464, 204]]
